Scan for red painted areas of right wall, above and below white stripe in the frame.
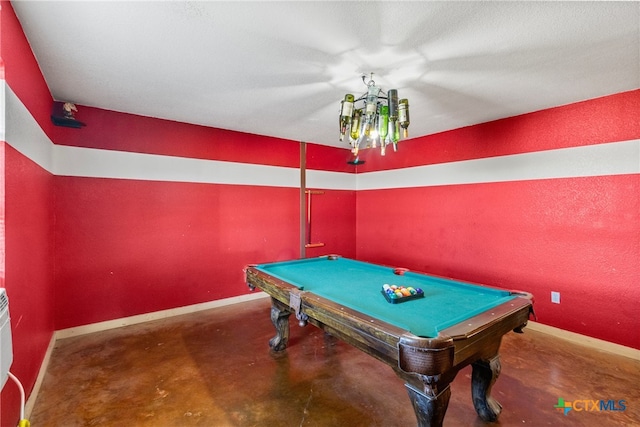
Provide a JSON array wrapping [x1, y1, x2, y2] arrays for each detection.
[[356, 90, 640, 348]]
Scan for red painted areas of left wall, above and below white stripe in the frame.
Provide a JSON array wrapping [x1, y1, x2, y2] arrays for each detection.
[[0, 1, 54, 426]]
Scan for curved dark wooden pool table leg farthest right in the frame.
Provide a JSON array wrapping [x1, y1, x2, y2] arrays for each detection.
[[471, 355, 502, 422]]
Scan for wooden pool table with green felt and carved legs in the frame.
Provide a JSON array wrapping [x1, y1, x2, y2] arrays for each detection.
[[245, 255, 533, 427]]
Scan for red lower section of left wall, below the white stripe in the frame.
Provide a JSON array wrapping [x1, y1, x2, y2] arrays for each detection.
[[2, 145, 54, 412]]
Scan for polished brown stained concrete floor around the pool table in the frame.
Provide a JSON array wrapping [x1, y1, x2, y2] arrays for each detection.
[[30, 299, 640, 427]]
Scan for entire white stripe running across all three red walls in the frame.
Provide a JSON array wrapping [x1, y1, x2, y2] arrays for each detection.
[[0, 80, 640, 190]]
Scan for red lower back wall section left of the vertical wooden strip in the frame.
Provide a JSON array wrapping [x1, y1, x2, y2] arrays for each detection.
[[55, 177, 299, 329]]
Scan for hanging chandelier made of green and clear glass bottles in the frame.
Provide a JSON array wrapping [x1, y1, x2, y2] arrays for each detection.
[[340, 73, 409, 156]]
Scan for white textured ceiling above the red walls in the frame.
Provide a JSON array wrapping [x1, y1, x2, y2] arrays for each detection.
[[12, 0, 640, 148]]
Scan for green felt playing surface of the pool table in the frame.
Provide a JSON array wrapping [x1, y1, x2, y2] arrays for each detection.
[[256, 257, 515, 337]]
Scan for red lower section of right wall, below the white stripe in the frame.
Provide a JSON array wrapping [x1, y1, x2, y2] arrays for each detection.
[[357, 175, 640, 348]]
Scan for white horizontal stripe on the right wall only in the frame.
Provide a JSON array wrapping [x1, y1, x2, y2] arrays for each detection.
[[356, 140, 640, 190]]
